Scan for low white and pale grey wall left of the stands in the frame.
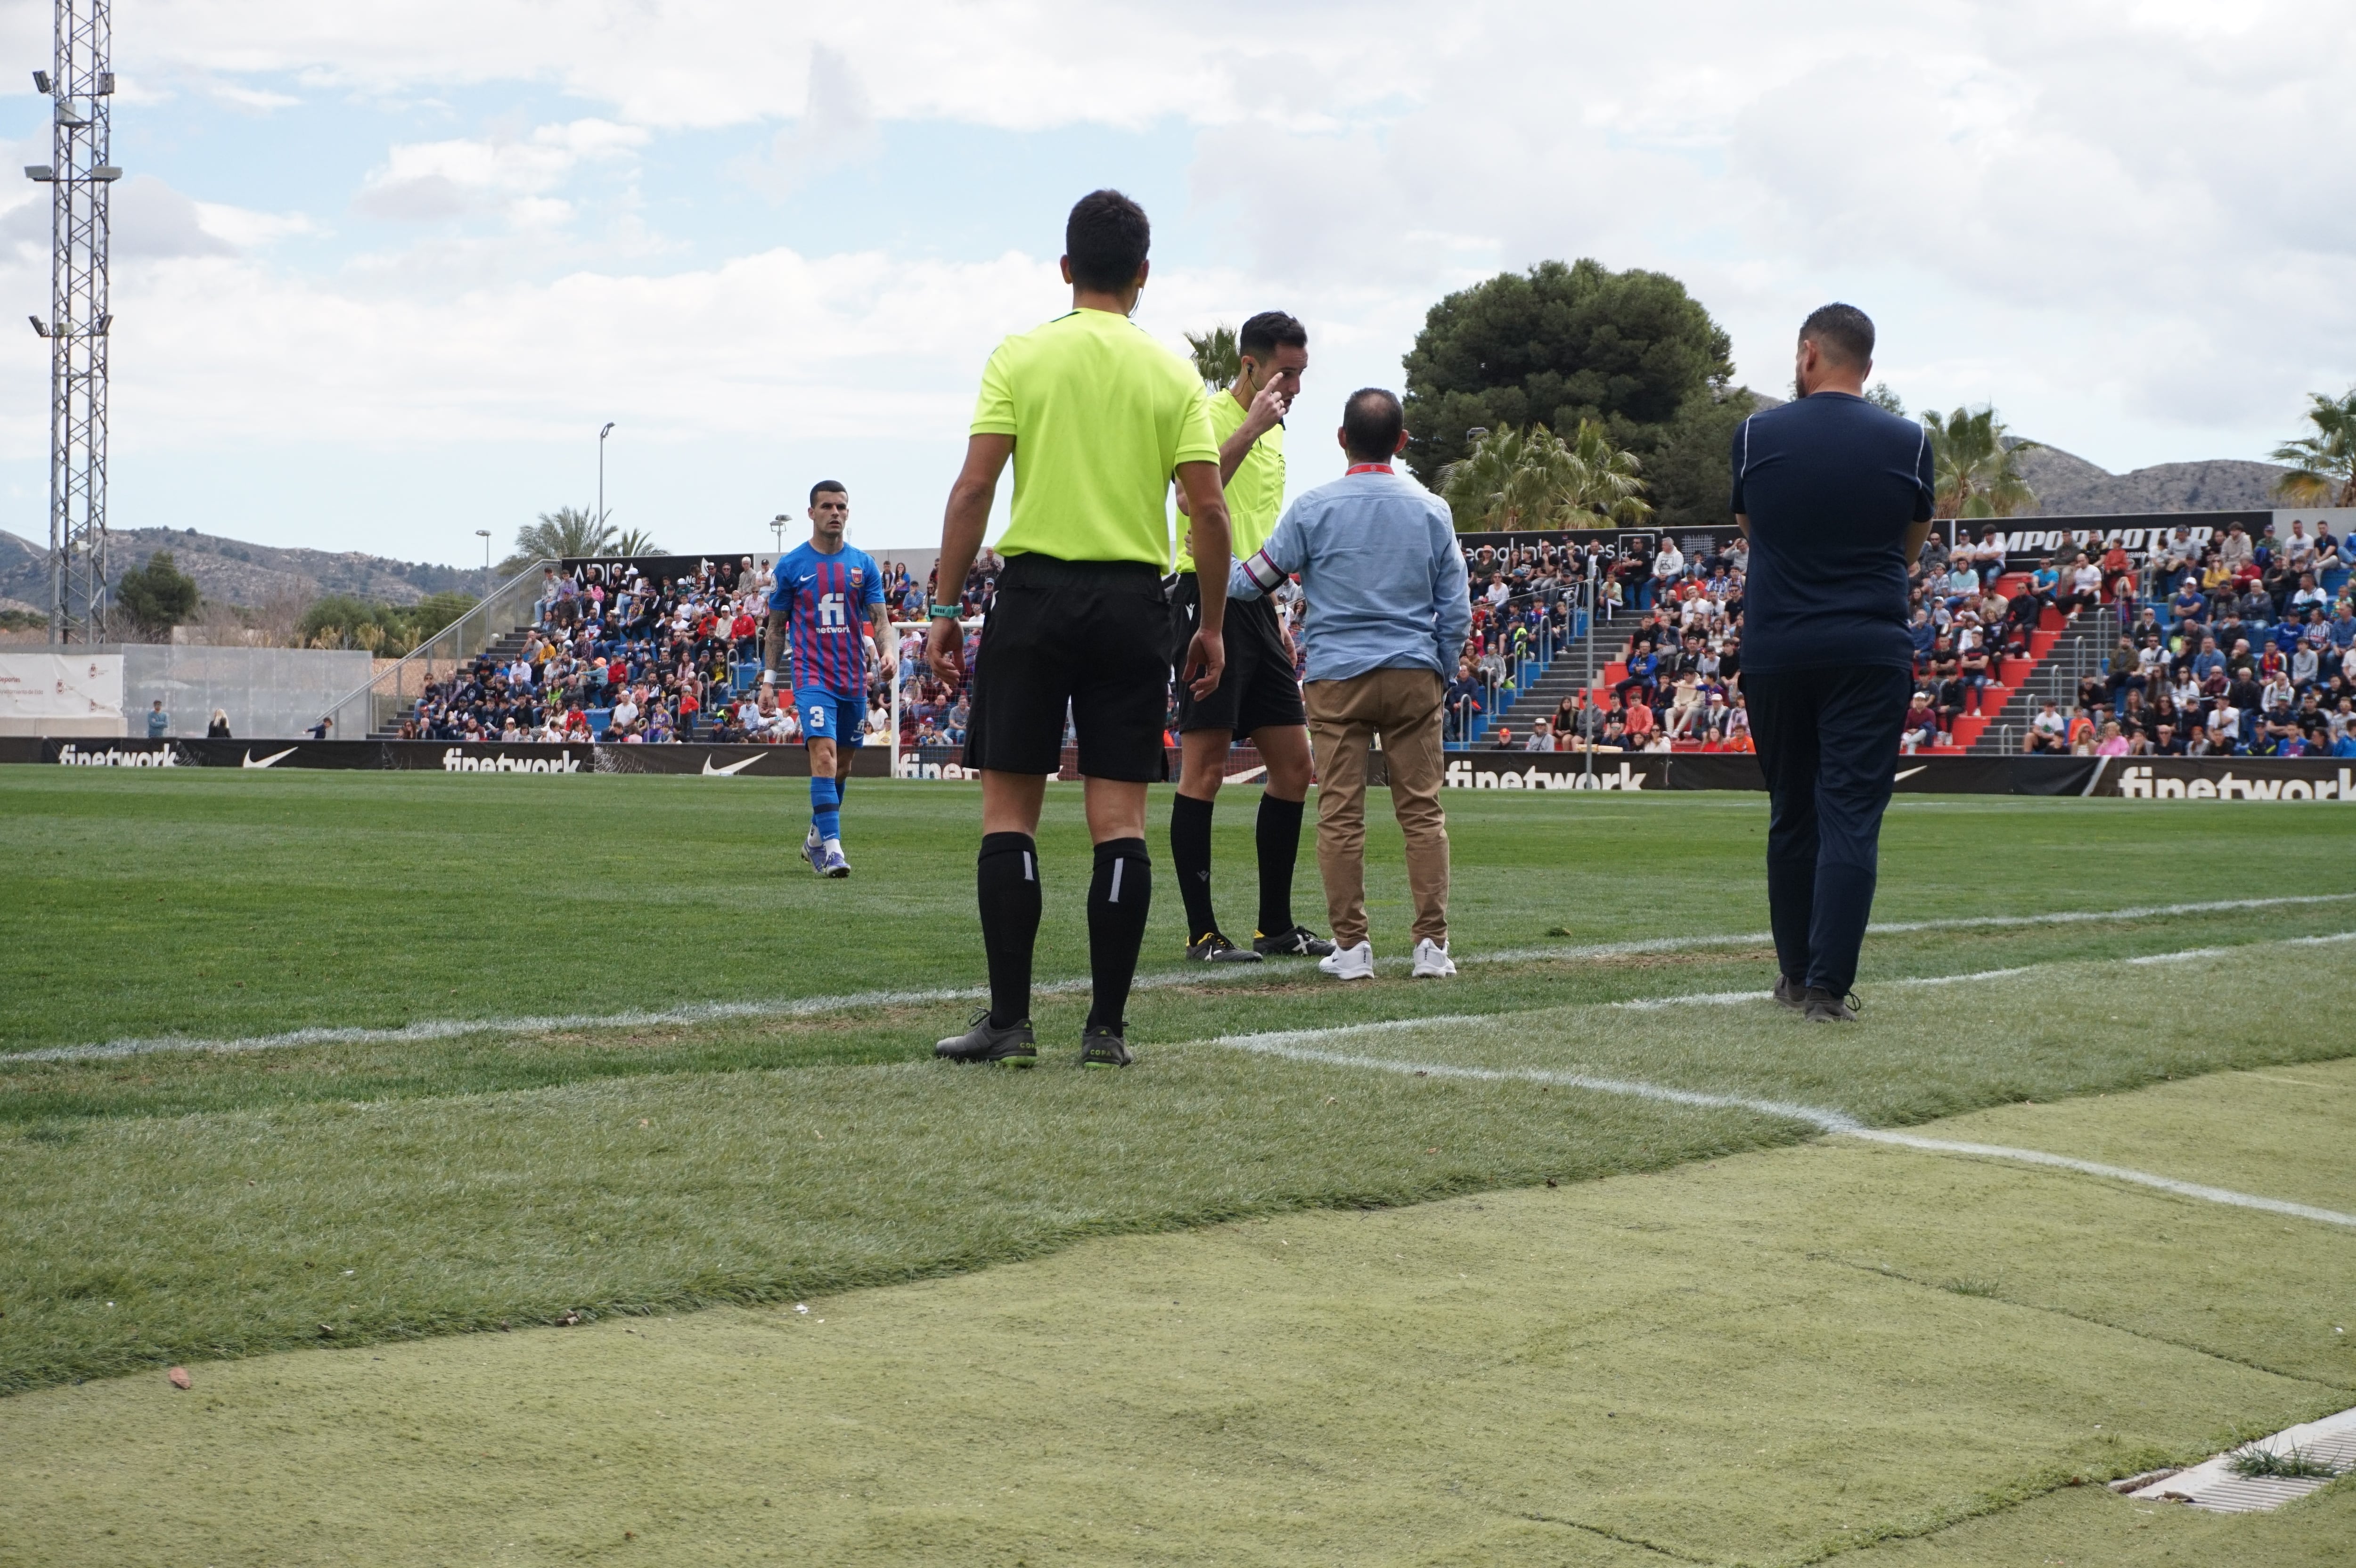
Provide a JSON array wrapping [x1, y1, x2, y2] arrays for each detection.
[[0, 643, 372, 739]]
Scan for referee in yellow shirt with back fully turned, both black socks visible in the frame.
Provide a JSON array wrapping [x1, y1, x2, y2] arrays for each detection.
[[926, 191, 1230, 1067]]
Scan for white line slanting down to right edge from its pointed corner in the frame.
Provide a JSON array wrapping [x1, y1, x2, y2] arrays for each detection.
[[1204, 1007, 2356, 1229]]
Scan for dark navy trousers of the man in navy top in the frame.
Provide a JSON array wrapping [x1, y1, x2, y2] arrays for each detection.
[[1743, 664, 1913, 996]]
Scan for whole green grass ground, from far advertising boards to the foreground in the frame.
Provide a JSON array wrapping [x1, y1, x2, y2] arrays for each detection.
[[0, 768, 2356, 1563]]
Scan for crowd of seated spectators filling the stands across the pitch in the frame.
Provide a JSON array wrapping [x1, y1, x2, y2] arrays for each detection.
[[401, 520, 2356, 756]]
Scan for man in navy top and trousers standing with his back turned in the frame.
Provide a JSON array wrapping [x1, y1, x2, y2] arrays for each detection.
[[1734, 304, 1932, 1022]]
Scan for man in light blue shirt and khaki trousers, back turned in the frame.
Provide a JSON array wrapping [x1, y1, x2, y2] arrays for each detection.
[[1227, 386, 1472, 980]]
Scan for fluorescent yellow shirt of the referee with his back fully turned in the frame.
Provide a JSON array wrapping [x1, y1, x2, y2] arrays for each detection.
[[973, 311, 1232, 570]]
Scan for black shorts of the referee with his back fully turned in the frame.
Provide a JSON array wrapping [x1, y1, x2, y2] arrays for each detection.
[[966, 555, 1171, 784]]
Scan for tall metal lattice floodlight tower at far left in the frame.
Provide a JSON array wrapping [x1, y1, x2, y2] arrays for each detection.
[[26, 0, 123, 643]]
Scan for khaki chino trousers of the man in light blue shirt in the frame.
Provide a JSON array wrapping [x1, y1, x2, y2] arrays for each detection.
[[1301, 669, 1449, 947]]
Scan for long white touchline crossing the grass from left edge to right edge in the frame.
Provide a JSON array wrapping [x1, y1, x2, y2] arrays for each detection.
[[18, 892, 2356, 1062]]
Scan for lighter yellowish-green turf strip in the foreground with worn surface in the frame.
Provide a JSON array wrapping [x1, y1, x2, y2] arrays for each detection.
[[0, 1067, 2356, 1568]]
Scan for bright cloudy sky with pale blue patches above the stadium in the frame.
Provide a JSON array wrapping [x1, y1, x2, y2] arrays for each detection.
[[0, 0, 2356, 563]]
